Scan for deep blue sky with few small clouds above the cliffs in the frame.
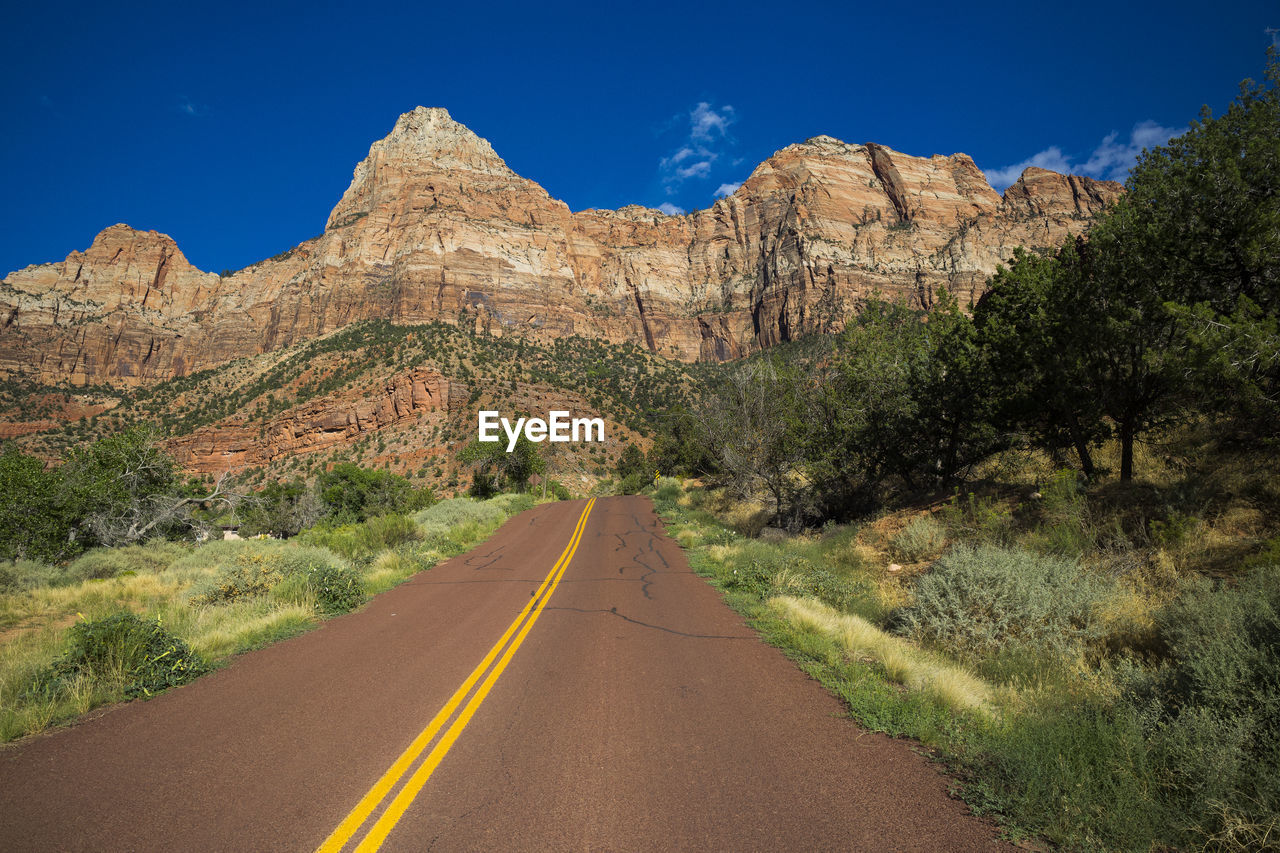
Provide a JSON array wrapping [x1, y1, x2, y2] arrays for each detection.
[[0, 0, 1280, 274]]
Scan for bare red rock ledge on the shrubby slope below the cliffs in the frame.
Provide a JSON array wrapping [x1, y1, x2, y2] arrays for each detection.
[[166, 369, 451, 474]]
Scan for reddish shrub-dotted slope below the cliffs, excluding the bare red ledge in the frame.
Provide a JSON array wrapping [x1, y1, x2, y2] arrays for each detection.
[[0, 321, 703, 493]]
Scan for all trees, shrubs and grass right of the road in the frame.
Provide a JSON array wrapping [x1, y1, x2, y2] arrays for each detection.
[[649, 60, 1280, 850]]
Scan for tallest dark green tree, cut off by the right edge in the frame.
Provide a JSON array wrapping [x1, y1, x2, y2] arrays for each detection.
[[1116, 55, 1280, 434]]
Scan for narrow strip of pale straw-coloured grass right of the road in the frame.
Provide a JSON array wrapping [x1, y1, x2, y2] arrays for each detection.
[[768, 596, 993, 713]]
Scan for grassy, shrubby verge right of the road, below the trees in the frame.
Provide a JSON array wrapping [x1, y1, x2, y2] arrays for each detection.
[[654, 480, 1280, 850]]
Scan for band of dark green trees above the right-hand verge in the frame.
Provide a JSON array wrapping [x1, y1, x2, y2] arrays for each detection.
[[654, 54, 1280, 530]]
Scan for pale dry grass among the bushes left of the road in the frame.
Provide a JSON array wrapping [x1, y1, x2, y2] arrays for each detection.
[[0, 496, 531, 742]]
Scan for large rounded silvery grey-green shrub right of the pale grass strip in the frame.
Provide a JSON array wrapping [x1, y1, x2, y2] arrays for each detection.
[[895, 544, 1112, 657]]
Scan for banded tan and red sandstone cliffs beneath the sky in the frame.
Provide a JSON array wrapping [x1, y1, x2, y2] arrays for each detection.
[[0, 108, 1121, 386]]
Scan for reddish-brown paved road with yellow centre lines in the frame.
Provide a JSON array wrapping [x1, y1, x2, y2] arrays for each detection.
[[0, 497, 1001, 852]]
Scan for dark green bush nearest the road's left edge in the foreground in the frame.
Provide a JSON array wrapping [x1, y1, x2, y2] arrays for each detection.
[[31, 611, 209, 697]]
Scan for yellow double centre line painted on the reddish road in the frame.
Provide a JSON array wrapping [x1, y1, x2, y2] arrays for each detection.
[[317, 498, 595, 853]]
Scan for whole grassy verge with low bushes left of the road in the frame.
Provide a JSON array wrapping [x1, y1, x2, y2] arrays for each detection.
[[0, 494, 534, 742]]
